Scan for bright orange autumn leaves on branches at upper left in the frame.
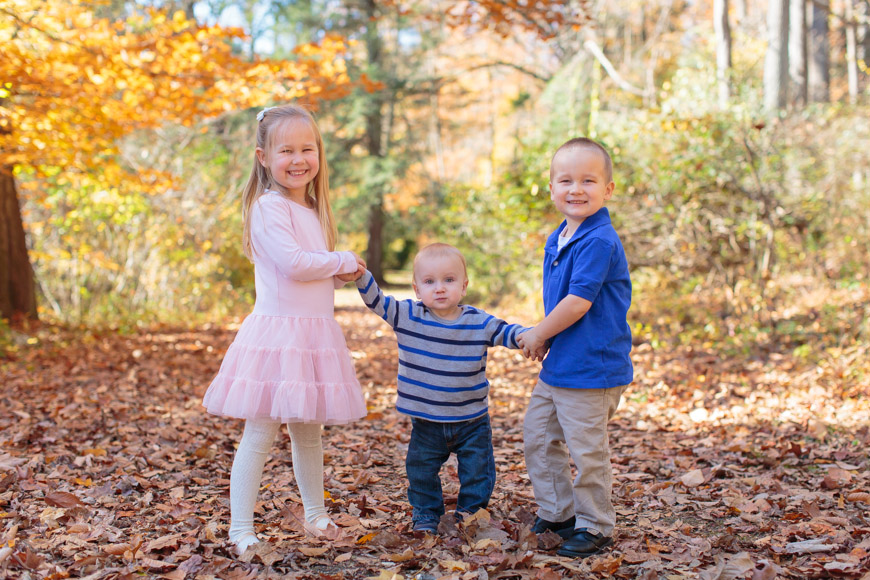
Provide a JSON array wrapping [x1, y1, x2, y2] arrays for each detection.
[[0, 0, 350, 196]]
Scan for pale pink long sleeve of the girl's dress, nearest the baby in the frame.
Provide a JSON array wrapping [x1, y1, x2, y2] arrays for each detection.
[[251, 195, 356, 282]]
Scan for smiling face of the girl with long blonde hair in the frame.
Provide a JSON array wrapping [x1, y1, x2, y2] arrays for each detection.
[[257, 119, 320, 204]]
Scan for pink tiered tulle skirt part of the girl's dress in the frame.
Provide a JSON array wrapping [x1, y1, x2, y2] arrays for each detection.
[[202, 314, 366, 425]]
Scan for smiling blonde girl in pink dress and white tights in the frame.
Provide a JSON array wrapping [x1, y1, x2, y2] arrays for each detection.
[[203, 105, 366, 554]]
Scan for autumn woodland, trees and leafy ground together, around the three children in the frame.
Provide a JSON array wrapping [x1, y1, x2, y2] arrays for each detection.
[[0, 0, 870, 580]]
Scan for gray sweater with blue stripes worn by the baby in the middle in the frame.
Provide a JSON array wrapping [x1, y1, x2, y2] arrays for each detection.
[[356, 270, 527, 423]]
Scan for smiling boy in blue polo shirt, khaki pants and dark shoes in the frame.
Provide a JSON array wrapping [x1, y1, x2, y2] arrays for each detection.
[[518, 138, 633, 558]]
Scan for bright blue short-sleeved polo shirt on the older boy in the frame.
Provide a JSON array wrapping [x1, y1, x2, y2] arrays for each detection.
[[540, 207, 634, 389]]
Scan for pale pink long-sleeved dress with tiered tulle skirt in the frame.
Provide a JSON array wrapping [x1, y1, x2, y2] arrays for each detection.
[[203, 191, 366, 425]]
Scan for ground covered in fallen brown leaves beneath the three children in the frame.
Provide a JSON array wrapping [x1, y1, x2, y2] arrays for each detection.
[[0, 307, 870, 580]]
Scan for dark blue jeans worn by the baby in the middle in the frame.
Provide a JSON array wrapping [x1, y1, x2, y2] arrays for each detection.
[[405, 415, 495, 524]]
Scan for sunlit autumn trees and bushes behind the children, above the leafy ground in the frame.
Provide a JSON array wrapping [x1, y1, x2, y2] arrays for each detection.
[[0, 0, 870, 332]]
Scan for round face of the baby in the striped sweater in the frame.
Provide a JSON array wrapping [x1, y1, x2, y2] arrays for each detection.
[[413, 255, 468, 319]]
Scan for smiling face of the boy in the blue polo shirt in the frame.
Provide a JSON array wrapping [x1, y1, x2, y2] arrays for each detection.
[[550, 147, 613, 230]]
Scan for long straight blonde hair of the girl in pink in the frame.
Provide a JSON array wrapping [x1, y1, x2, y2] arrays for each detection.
[[242, 105, 338, 260]]
